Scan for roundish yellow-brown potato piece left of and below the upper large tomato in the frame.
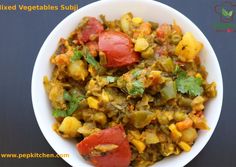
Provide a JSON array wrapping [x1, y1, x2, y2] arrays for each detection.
[[68, 60, 88, 81]]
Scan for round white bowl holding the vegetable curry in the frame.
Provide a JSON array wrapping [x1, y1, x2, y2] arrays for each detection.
[[31, 0, 223, 167]]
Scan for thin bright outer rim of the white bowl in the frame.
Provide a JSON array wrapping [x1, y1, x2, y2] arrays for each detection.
[[31, 0, 223, 166]]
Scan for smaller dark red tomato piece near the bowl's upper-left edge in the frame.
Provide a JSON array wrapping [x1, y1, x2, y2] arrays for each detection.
[[80, 17, 104, 43]]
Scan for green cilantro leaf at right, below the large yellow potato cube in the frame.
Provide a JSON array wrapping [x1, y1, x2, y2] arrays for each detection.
[[175, 68, 203, 96]]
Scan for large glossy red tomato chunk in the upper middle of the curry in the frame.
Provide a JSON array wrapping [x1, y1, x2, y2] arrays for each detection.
[[98, 31, 139, 67]]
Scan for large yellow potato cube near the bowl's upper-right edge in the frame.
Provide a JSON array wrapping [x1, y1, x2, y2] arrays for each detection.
[[175, 32, 203, 62]]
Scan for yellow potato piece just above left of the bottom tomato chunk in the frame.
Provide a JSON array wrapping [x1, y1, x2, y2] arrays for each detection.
[[58, 116, 81, 138]]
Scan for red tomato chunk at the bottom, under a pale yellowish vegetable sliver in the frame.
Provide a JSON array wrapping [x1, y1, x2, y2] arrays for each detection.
[[77, 125, 131, 167]]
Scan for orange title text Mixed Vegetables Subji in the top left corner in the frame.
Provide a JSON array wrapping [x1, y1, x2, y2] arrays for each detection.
[[0, 4, 79, 12]]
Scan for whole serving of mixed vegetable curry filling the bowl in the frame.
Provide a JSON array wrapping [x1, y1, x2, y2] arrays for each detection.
[[44, 13, 216, 167]]
